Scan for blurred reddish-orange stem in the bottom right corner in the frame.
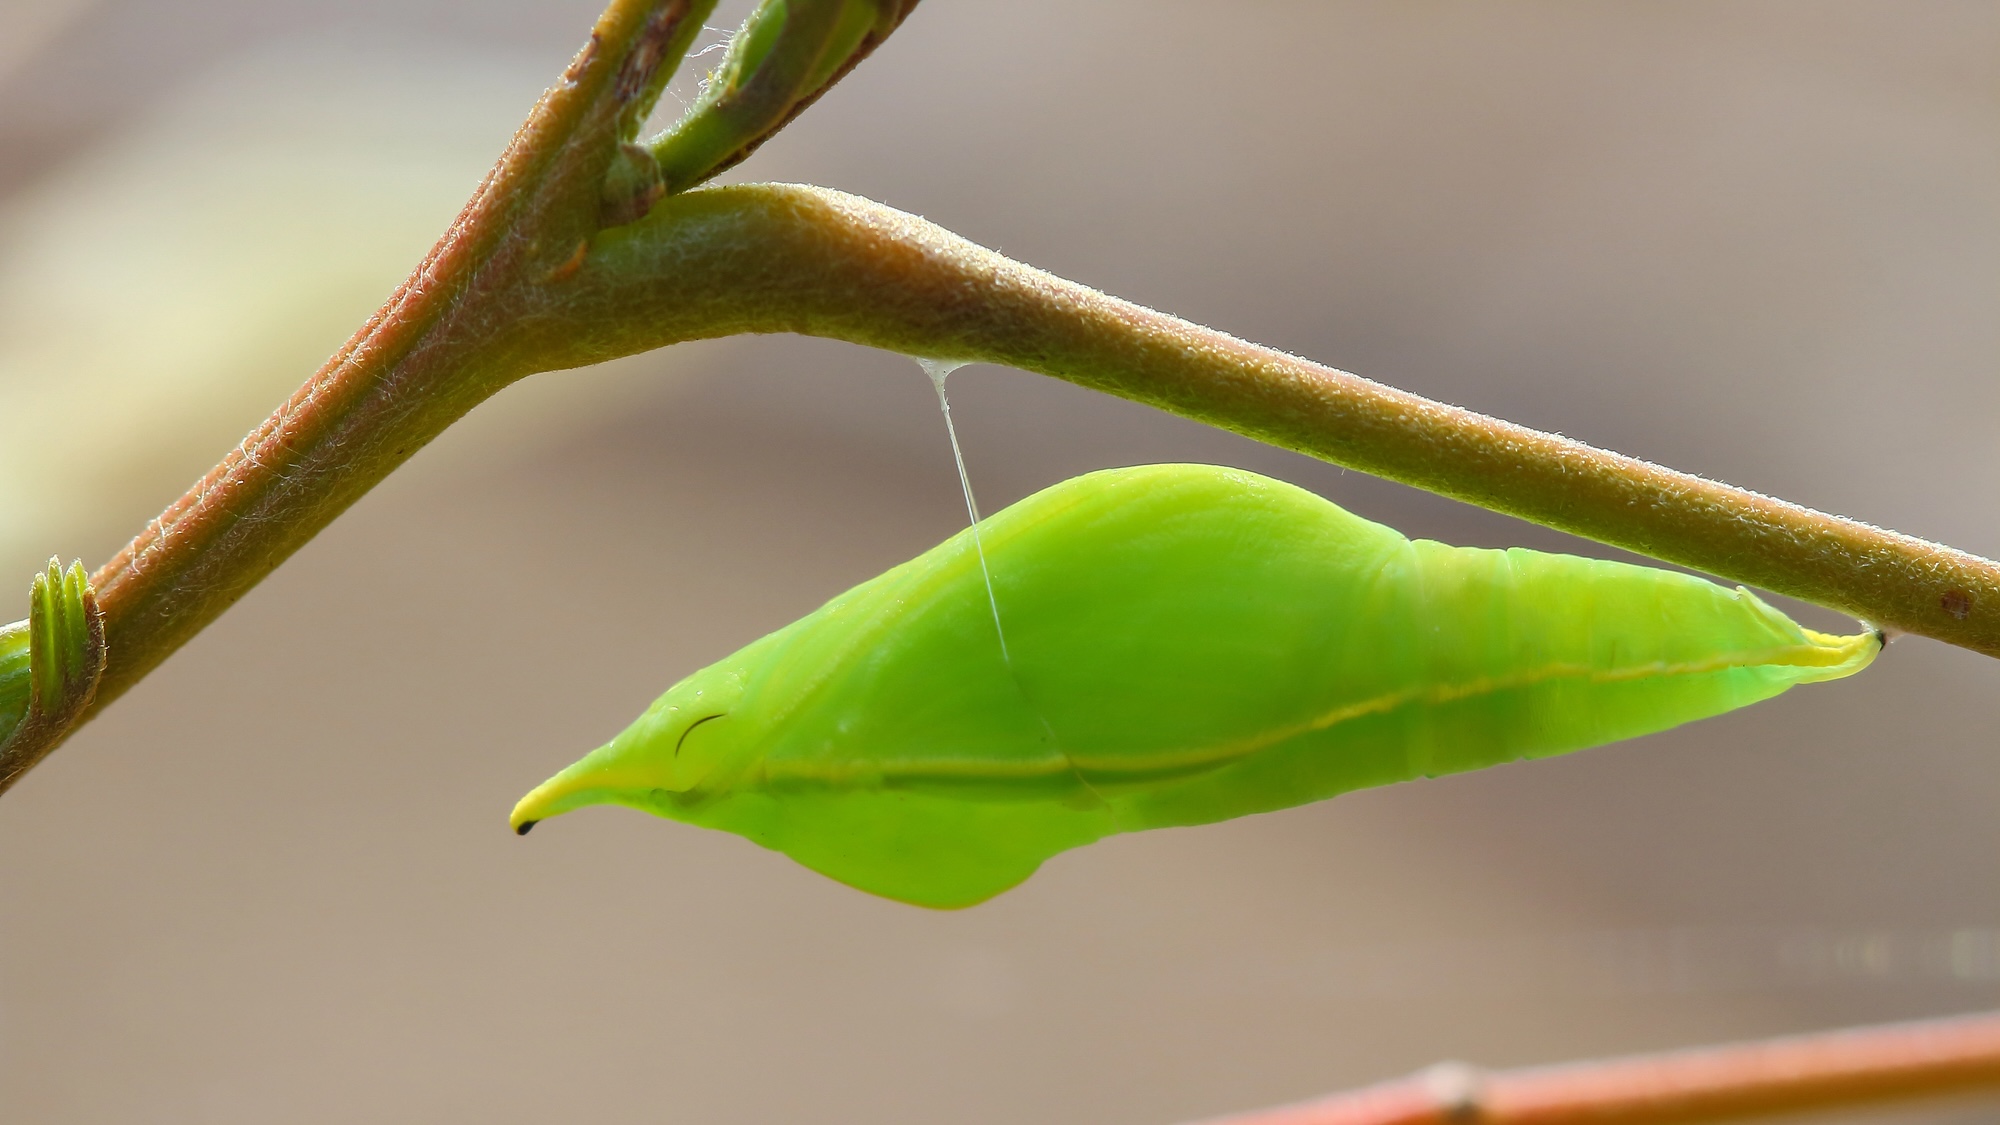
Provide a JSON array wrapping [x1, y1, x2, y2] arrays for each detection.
[[1176, 1013, 2000, 1125]]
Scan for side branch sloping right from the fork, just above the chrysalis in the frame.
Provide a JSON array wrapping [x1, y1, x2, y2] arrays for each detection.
[[540, 184, 2000, 657]]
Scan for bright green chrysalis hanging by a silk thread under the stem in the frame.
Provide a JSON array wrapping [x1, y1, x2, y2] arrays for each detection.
[[512, 464, 1882, 907]]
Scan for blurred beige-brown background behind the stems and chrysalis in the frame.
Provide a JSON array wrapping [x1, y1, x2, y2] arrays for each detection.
[[0, 0, 2000, 1125]]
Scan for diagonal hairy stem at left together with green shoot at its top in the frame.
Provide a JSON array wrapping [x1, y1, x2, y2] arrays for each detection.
[[0, 0, 944, 791]]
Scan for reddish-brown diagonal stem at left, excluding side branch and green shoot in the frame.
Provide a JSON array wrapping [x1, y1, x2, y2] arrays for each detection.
[[76, 0, 714, 709]]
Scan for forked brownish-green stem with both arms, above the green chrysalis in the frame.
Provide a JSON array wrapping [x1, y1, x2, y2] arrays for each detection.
[[19, 0, 2000, 789]]
